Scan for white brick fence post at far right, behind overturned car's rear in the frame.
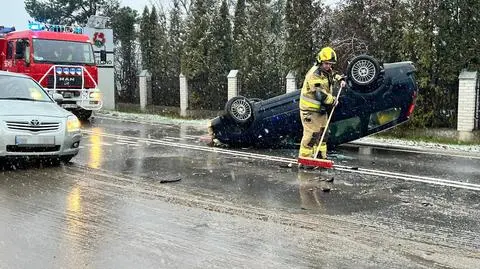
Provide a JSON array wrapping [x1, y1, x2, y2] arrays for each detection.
[[457, 71, 477, 140]]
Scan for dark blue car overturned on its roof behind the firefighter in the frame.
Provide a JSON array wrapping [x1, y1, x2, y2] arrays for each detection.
[[209, 55, 418, 148]]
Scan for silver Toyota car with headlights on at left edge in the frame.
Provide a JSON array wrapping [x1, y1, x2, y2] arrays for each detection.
[[0, 71, 82, 163]]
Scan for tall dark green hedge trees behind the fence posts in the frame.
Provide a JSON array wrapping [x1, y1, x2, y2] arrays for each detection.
[[25, 0, 480, 124]]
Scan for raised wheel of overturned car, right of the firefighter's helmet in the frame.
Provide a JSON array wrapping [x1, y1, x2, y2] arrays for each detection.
[[347, 55, 380, 86]]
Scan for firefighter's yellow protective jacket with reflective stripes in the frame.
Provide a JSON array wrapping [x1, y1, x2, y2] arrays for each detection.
[[300, 65, 343, 112]]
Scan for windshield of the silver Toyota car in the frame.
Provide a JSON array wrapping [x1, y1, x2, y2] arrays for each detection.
[[0, 76, 52, 102]]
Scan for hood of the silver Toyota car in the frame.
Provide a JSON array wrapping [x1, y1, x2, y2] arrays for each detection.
[[0, 100, 72, 118]]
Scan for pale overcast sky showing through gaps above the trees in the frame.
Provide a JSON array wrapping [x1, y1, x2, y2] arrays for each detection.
[[0, 0, 337, 30]]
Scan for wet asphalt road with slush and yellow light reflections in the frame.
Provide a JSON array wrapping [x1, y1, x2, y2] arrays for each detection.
[[0, 115, 480, 268]]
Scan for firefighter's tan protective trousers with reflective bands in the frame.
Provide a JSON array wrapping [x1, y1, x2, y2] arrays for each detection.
[[298, 110, 328, 159]]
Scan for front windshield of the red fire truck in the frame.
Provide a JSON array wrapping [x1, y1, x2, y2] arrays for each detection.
[[33, 39, 95, 65]]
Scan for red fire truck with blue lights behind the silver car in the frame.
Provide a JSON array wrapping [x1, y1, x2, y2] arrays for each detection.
[[0, 23, 102, 120]]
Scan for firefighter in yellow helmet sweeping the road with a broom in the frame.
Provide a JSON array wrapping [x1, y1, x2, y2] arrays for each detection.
[[299, 47, 346, 159]]
